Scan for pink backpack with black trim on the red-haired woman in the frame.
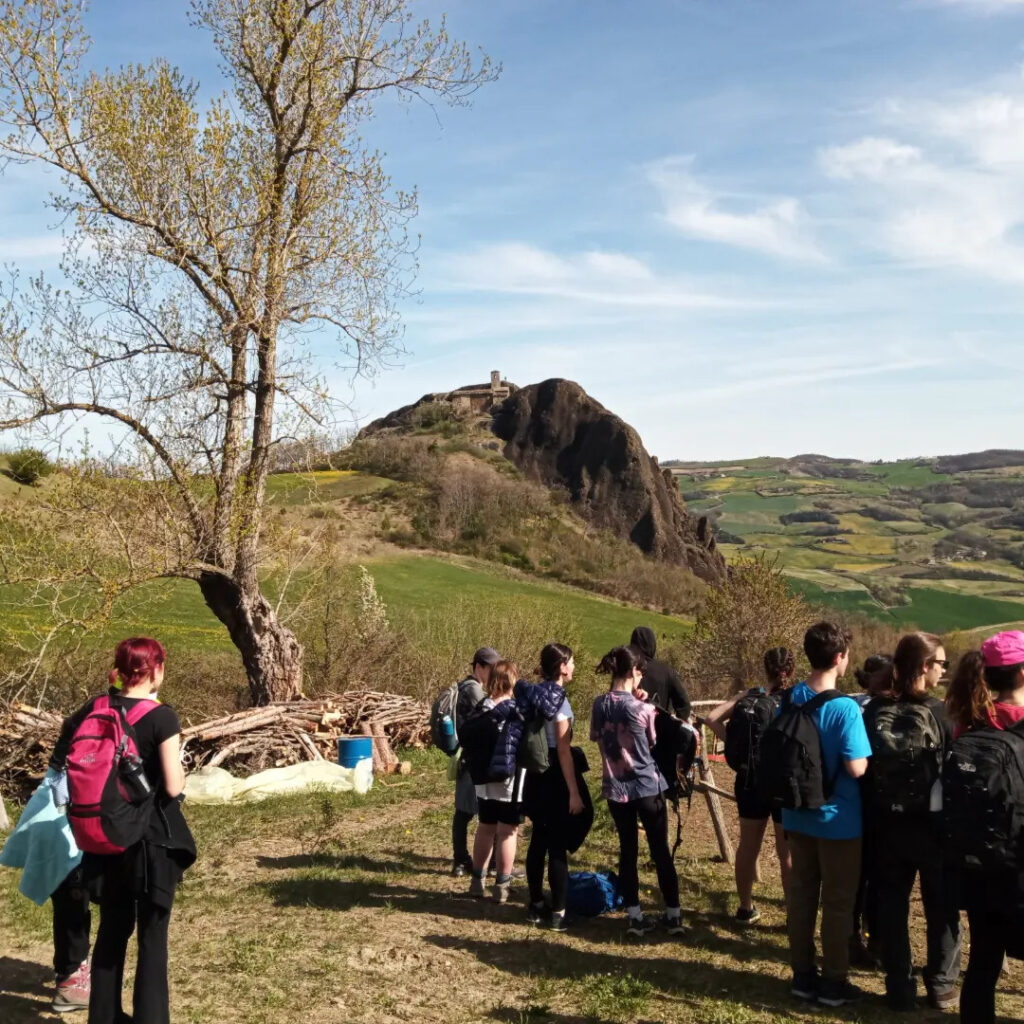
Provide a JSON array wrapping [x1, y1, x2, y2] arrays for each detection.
[[68, 696, 160, 854]]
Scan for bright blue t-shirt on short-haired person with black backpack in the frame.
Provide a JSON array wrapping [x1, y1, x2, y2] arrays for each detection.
[[782, 683, 871, 839]]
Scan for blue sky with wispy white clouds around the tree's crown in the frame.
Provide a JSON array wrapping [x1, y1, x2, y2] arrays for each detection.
[[6, 0, 1024, 459]]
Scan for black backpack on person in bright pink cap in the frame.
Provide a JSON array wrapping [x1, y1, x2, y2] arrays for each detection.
[[942, 726, 1024, 873]]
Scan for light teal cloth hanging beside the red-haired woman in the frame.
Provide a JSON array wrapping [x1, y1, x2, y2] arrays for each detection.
[[0, 768, 82, 905]]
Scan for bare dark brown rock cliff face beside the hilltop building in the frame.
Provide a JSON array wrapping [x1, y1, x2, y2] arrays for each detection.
[[492, 379, 726, 583]]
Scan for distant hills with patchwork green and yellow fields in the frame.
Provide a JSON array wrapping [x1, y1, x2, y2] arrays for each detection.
[[665, 450, 1024, 632]]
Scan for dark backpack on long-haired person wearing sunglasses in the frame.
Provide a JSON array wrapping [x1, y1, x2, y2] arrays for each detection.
[[864, 697, 945, 815]]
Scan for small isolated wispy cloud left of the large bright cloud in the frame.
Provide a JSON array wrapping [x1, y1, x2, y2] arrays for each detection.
[[647, 157, 824, 262]]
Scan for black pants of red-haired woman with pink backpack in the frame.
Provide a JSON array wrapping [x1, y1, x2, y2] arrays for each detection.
[[89, 879, 171, 1024]]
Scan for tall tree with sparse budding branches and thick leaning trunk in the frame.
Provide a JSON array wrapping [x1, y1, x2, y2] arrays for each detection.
[[0, 0, 498, 701]]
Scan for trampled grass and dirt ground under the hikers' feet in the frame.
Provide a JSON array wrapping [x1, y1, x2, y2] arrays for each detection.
[[0, 752, 1024, 1024]]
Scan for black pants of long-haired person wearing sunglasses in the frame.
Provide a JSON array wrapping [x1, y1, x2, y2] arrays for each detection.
[[871, 818, 962, 999]]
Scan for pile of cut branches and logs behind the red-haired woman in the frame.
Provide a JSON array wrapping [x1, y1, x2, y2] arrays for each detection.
[[0, 690, 430, 798]]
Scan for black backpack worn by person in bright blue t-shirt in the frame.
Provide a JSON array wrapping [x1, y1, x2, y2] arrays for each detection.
[[757, 690, 850, 811]]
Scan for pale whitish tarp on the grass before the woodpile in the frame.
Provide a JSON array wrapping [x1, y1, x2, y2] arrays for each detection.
[[185, 758, 374, 804]]
